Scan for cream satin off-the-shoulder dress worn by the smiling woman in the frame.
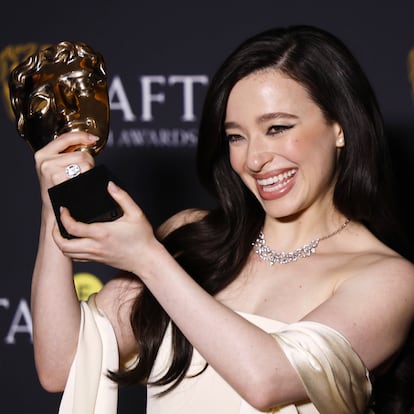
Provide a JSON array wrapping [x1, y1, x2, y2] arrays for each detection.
[[59, 296, 371, 414]]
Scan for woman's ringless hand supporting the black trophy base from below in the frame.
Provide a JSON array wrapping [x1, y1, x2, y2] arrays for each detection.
[[53, 182, 159, 274]]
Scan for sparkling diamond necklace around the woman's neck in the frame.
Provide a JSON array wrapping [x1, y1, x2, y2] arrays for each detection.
[[252, 219, 350, 266]]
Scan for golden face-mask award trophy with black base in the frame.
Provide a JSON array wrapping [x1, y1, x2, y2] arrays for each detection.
[[9, 41, 122, 238]]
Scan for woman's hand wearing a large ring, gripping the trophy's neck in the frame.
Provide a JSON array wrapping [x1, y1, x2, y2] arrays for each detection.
[[34, 132, 98, 206]]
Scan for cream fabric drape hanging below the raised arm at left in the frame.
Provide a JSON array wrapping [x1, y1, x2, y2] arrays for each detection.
[[59, 295, 119, 414]]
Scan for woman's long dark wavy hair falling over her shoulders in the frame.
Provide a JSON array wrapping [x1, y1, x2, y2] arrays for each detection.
[[114, 26, 412, 414]]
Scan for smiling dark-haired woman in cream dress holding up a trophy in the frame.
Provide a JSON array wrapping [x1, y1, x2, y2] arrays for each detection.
[[32, 26, 414, 414]]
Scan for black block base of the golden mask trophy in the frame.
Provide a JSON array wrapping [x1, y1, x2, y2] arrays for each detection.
[[48, 165, 123, 239]]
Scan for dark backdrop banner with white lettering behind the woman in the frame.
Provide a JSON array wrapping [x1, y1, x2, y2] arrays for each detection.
[[0, 0, 414, 414]]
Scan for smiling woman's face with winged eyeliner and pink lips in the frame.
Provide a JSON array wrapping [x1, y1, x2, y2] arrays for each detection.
[[225, 69, 343, 218]]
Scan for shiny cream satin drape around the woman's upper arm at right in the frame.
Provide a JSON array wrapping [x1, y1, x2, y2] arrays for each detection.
[[271, 321, 372, 414]]
